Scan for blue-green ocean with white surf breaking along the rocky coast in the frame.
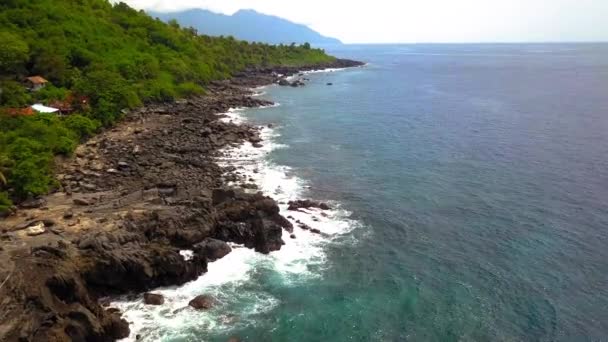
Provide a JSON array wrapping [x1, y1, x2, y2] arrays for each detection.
[[116, 44, 608, 342]]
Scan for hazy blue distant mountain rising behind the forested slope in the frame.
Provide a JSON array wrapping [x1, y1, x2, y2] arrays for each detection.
[[149, 9, 342, 45]]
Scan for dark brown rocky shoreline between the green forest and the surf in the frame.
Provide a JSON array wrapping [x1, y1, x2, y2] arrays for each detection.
[[0, 60, 362, 341]]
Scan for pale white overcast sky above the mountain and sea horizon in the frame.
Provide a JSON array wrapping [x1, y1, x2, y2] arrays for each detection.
[[123, 0, 608, 43]]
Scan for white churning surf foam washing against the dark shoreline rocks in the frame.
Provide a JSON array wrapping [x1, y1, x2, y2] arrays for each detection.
[[113, 91, 357, 341]]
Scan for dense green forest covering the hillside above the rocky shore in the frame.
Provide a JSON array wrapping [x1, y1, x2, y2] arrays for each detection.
[[0, 0, 333, 212]]
